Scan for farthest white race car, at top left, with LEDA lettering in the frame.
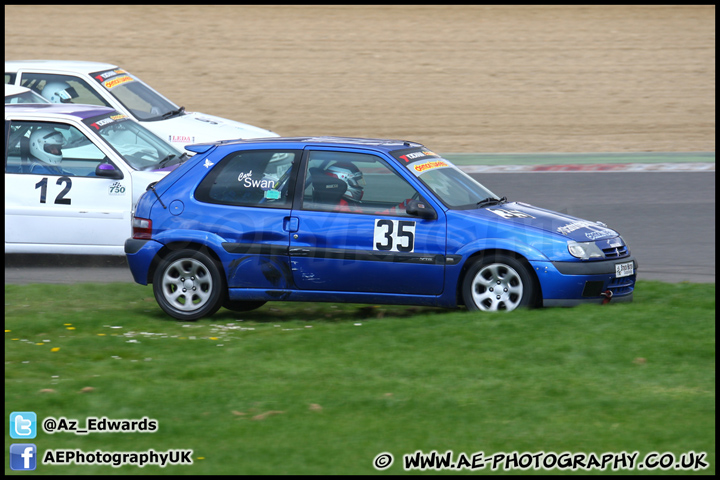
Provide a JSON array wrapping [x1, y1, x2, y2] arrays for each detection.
[[5, 60, 279, 148]]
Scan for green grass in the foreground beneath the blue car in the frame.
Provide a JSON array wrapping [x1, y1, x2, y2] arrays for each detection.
[[5, 281, 715, 475]]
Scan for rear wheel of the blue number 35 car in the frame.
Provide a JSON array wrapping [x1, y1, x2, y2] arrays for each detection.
[[153, 250, 227, 321]]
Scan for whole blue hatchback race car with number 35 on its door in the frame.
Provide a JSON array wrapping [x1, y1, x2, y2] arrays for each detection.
[[125, 137, 637, 320]]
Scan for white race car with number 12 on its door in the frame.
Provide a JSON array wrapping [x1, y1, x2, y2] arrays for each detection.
[[5, 104, 189, 255]]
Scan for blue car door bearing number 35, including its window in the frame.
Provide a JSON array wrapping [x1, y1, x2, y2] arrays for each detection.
[[289, 147, 446, 295]]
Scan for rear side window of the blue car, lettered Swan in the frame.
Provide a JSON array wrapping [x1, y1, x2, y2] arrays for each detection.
[[195, 150, 301, 208]]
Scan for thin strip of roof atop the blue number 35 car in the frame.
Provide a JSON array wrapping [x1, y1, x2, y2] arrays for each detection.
[[185, 137, 423, 153]]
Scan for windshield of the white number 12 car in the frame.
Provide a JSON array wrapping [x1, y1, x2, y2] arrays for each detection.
[[82, 113, 188, 170]]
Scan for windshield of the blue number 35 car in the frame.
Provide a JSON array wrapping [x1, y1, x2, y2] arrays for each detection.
[[416, 158, 497, 210]]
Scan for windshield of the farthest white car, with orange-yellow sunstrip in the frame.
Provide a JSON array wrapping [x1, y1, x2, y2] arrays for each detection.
[[90, 68, 184, 122]]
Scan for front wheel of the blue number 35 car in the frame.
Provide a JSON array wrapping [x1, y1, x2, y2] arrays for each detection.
[[462, 254, 536, 312]]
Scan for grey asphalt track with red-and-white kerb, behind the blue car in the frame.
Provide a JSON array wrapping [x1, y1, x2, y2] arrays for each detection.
[[5, 153, 715, 284]]
